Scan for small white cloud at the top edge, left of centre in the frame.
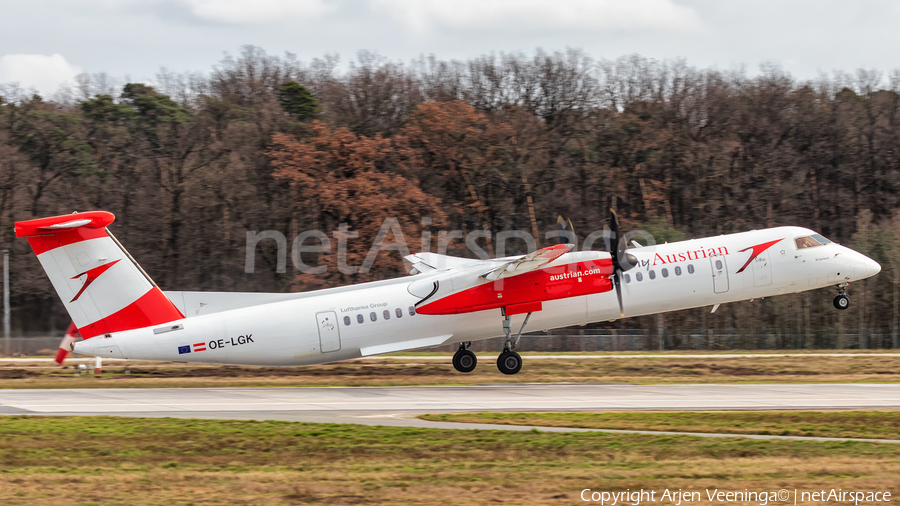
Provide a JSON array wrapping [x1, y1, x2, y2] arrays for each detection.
[[180, 0, 333, 24]]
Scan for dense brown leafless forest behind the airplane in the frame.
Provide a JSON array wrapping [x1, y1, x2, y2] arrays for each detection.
[[0, 47, 900, 346]]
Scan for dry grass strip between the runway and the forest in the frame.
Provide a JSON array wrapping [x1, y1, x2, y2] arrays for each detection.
[[0, 353, 900, 388]]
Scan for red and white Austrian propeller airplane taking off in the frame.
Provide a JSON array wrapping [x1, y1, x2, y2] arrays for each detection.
[[15, 211, 881, 374]]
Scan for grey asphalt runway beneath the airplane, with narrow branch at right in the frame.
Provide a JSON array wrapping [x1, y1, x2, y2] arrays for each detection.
[[0, 383, 900, 443]]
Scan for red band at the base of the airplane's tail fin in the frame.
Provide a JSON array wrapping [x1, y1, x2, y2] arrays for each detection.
[[78, 286, 184, 339]]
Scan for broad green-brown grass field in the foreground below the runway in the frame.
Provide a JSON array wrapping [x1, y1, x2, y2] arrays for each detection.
[[0, 417, 900, 505]]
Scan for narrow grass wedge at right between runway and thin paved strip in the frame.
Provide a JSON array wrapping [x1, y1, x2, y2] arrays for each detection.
[[421, 411, 900, 440]]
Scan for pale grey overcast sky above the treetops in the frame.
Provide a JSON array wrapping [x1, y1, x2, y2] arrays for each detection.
[[0, 0, 900, 94]]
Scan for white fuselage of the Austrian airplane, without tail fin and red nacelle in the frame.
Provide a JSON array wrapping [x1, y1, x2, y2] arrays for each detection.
[[74, 227, 881, 366]]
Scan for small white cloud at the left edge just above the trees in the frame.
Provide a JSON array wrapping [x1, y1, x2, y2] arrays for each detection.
[[0, 54, 81, 95]]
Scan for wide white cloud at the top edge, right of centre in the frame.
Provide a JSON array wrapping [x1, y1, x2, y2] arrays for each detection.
[[370, 0, 702, 33]]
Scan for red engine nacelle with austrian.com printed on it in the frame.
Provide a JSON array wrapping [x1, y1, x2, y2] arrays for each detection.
[[416, 258, 613, 314]]
